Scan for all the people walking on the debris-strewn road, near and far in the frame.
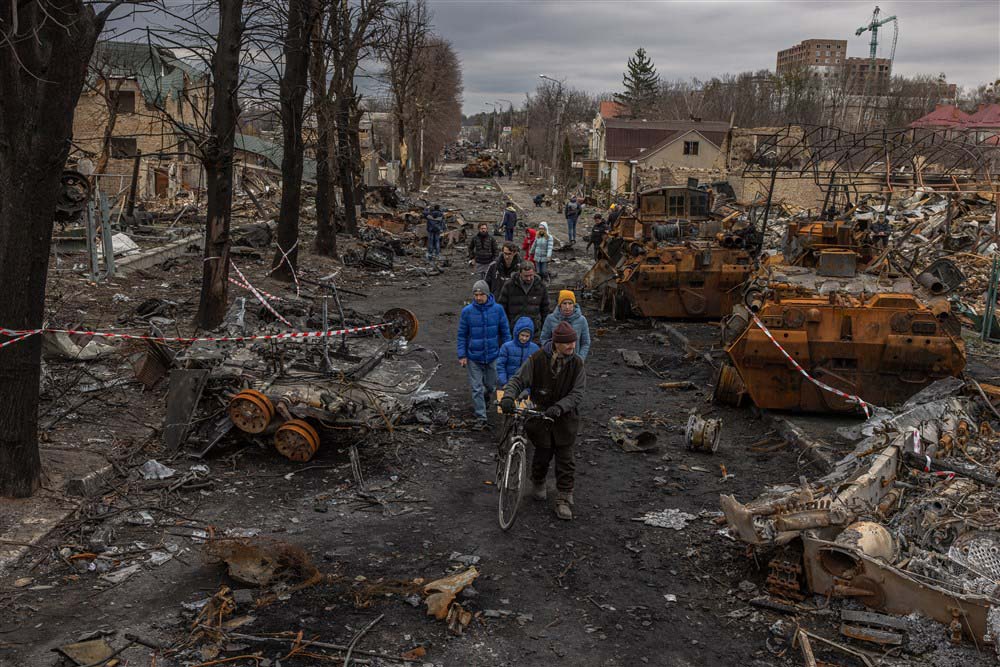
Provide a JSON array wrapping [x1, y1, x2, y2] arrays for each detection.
[[426, 192, 620, 520]]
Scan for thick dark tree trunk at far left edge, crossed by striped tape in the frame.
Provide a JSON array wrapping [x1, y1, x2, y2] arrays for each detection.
[[0, 0, 103, 497]]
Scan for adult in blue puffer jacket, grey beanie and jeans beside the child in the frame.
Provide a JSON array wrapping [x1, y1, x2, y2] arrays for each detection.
[[456, 280, 510, 429]]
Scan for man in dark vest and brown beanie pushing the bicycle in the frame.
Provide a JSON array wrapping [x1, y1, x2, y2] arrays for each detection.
[[500, 322, 586, 521]]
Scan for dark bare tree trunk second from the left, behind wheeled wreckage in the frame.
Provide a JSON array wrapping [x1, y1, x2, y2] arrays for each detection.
[[197, 0, 243, 329]]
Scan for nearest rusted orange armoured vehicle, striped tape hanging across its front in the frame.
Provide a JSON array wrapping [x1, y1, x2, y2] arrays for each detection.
[[715, 221, 965, 412]]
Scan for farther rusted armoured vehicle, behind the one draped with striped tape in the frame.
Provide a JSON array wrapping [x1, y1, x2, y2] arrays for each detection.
[[584, 184, 753, 319]]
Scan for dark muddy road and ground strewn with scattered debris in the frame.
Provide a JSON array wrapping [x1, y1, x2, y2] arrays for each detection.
[[0, 165, 986, 667]]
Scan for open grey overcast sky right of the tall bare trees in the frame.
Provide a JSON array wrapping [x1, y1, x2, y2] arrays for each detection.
[[429, 0, 1000, 114]]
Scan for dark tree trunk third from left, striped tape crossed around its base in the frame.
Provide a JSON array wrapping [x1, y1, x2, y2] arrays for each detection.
[[271, 0, 317, 280]]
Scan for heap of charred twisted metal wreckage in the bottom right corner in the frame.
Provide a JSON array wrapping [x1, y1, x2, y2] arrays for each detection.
[[721, 378, 1000, 647]]
